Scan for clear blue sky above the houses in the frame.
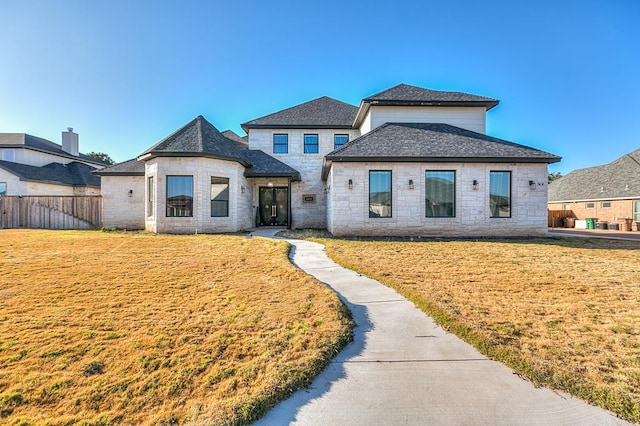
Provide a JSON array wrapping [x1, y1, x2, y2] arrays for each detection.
[[0, 0, 640, 174]]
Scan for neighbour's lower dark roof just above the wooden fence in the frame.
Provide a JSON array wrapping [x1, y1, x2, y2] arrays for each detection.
[[0, 161, 100, 188]]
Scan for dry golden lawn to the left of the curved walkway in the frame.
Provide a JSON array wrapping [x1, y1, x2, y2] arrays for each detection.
[[0, 230, 351, 425]]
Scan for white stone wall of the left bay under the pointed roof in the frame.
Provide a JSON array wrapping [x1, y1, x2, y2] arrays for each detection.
[[143, 157, 253, 234]]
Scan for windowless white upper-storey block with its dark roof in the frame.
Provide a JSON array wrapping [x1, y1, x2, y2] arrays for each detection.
[[353, 84, 499, 135]]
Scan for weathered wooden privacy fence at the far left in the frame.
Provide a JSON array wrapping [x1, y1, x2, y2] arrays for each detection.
[[0, 196, 102, 229]]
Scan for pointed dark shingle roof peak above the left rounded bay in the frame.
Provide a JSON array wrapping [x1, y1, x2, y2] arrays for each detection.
[[138, 115, 249, 166]]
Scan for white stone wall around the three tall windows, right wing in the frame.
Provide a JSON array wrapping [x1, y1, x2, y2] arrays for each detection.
[[327, 162, 547, 237]]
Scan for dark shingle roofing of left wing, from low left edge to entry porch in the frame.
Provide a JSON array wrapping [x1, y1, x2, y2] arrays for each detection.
[[132, 115, 300, 180]]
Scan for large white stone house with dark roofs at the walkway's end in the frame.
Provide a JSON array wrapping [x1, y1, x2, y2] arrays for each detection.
[[97, 84, 560, 236]]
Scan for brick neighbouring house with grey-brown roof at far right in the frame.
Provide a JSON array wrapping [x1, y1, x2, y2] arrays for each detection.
[[549, 149, 640, 230]]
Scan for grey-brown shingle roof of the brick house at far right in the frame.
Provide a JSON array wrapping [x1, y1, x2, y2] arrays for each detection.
[[549, 149, 640, 202]]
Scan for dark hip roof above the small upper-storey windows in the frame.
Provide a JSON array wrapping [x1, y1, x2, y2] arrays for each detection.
[[242, 96, 358, 132]]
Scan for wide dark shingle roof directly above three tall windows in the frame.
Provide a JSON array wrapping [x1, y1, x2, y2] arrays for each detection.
[[326, 123, 560, 163]]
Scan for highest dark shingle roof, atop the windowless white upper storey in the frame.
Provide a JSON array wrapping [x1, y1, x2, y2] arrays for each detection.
[[353, 83, 500, 127]]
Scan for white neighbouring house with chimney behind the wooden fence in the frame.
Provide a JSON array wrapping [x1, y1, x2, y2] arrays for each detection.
[[0, 129, 106, 196]]
